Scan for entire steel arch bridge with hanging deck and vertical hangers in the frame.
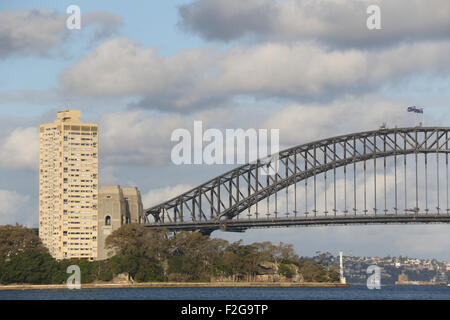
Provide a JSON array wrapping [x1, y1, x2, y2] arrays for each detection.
[[144, 127, 450, 234]]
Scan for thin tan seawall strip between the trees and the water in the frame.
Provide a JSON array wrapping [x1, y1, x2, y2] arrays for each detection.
[[0, 282, 350, 291]]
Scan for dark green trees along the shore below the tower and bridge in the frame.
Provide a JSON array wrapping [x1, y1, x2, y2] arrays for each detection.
[[0, 224, 340, 290]]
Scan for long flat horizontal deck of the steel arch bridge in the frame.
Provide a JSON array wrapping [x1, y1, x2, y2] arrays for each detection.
[[145, 213, 450, 234]]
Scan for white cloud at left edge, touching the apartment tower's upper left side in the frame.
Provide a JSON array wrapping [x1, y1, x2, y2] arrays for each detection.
[[0, 127, 39, 170]]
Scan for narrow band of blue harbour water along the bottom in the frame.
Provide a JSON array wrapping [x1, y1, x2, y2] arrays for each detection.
[[0, 286, 450, 300]]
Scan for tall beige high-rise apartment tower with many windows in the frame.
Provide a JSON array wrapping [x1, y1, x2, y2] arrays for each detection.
[[39, 110, 98, 260]]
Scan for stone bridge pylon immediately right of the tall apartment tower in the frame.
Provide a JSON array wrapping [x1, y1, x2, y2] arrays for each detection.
[[98, 186, 144, 260]]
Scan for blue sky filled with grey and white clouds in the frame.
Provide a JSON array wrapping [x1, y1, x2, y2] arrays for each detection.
[[0, 0, 450, 260]]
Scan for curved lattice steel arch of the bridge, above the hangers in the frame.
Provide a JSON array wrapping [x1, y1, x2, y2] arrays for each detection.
[[145, 127, 450, 223]]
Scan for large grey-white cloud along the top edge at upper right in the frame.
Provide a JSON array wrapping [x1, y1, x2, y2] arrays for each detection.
[[179, 0, 450, 47]]
